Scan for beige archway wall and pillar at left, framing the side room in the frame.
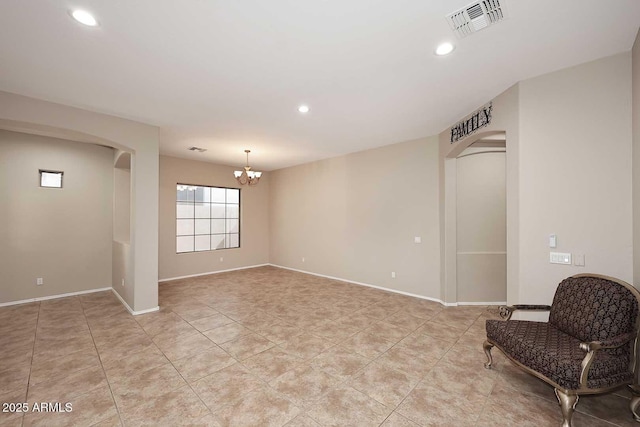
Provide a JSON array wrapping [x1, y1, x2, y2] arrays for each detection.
[[0, 92, 159, 314]]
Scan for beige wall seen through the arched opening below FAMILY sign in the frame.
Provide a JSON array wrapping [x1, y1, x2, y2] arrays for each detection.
[[456, 146, 507, 303]]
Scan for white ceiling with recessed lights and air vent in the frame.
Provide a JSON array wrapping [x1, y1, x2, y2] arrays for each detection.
[[0, 0, 640, 170]]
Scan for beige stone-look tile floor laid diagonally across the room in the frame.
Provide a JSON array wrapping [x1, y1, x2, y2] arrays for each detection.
[[0, 267, 635, 427]]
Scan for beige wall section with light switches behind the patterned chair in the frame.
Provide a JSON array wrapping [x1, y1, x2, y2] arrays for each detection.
[[520, 52, 633, 303]]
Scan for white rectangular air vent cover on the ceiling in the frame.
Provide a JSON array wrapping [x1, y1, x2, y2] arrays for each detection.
[[447, 0, 506, 38]]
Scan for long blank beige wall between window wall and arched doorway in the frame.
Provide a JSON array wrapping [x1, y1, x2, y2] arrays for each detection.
[[270, 137, 440, 299]]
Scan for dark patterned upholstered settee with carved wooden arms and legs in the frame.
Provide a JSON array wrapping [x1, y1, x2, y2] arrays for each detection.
[[484, 274, 640, 427]]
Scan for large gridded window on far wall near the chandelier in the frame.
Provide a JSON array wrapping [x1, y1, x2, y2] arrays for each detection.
[[176, 184, 240, 253]]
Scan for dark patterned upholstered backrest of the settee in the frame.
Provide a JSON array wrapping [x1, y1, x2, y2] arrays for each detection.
[[549, 274, 640, 342]]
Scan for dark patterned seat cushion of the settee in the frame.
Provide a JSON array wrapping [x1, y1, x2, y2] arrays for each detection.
[[486, 320, 633, 390]]
